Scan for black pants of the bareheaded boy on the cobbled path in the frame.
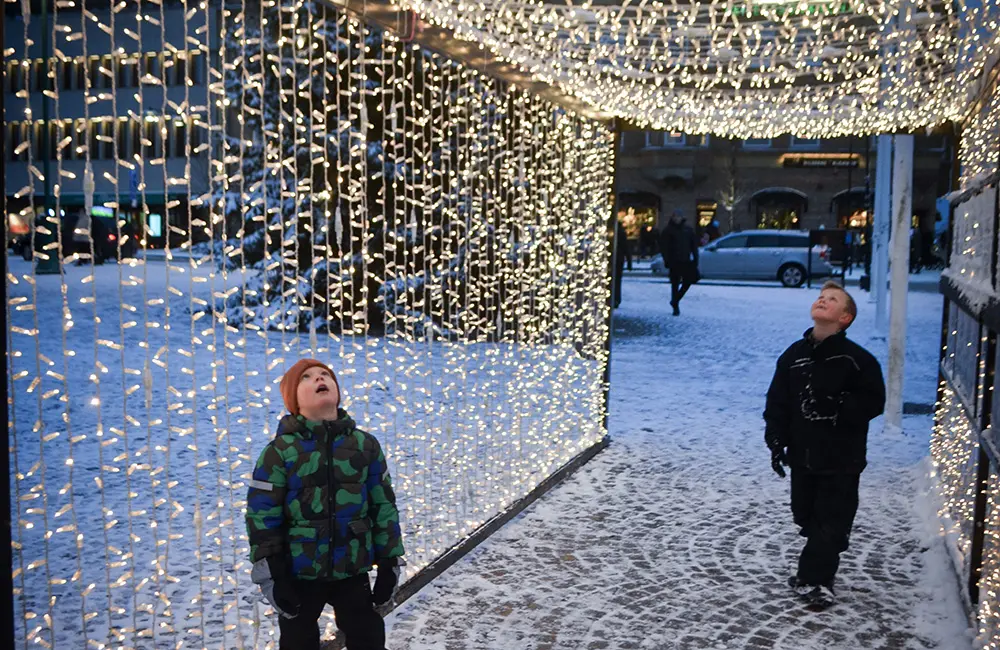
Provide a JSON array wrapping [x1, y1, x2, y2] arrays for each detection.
[[792, 469, 861, 587]]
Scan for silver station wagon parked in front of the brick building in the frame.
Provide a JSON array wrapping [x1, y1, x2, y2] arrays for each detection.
[[651, 230, 834, 287]]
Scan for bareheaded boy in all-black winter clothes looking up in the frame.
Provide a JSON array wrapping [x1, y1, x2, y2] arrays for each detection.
[[764, 282, 885, 609]]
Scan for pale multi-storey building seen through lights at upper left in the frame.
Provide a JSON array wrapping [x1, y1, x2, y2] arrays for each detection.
[[3, 0, 218, 247]]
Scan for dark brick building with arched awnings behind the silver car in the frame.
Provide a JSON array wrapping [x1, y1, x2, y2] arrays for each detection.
[[618, 131, 952, 246]]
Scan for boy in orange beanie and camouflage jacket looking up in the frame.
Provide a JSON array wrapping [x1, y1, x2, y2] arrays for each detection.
[[246, 359, 403, 650]]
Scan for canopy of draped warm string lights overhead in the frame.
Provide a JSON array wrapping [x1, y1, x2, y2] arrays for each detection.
[[402, 0, 998, 138]]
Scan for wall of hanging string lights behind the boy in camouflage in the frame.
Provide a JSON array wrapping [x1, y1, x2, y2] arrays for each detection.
[[5, 0, 614, 649]]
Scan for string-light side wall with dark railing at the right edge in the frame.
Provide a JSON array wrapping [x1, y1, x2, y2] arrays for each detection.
[[931, 38, 1000, 649]]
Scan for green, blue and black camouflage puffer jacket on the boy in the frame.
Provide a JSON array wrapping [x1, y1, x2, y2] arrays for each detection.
[[247, 409, 403, 580]]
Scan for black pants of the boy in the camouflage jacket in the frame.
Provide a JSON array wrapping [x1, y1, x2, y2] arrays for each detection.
[[278, 574, 385, 650]]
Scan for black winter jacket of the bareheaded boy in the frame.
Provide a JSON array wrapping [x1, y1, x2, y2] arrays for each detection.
[[764, 328, 885, 474]]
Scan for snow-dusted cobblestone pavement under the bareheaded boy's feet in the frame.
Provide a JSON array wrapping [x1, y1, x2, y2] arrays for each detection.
[[387, 277, 971, 650]]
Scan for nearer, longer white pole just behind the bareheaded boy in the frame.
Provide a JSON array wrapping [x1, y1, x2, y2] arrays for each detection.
[[885, 135, 913, 432]]
